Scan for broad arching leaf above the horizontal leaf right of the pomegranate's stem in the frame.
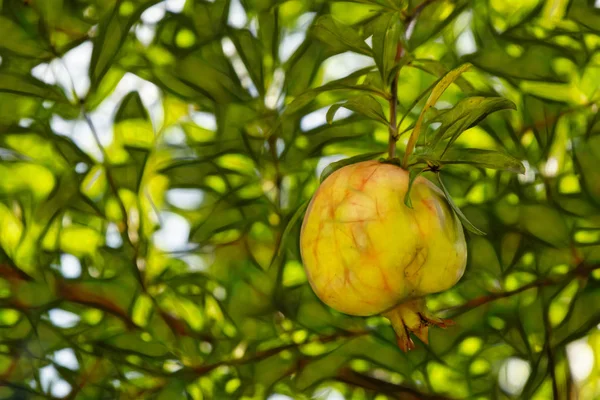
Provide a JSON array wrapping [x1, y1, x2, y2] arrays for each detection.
[[427, 96, 517, 149]]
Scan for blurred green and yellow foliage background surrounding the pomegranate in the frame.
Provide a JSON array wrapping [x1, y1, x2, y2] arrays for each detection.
[[0, 0, 600, 400]]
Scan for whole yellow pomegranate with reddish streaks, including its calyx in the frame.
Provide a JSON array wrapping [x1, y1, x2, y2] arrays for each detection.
[[300, 161, 467, 351]]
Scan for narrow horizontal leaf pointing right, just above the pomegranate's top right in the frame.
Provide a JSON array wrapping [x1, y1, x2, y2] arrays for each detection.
[[440, 148, 525, 174]]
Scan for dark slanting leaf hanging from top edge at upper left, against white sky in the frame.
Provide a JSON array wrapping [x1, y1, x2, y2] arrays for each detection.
[[90, 0, 159, 88]]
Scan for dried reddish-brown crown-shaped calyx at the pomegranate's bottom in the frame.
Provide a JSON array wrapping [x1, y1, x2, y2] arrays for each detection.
[[382, 298, 454, 352]]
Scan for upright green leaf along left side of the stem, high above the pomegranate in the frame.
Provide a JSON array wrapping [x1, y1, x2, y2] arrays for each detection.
[[373, 13, 402, 82]]
